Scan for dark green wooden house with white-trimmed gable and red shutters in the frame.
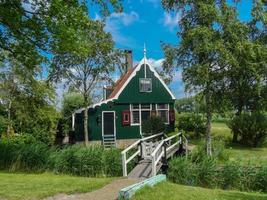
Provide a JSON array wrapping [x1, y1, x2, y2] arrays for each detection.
[[72, 51, 175, 147]]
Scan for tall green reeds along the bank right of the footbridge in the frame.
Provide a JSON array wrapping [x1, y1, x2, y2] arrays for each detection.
[[167, 151, 267, 192]]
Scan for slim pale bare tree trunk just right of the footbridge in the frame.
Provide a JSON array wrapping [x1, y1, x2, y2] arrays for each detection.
[[205, 89, 212, 156]]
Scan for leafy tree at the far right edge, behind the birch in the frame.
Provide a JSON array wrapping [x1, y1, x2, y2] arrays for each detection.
[[221, 3, 267, 142]]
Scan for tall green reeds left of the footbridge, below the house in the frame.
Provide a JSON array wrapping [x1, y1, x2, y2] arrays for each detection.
[[0, 138, 122, 176]]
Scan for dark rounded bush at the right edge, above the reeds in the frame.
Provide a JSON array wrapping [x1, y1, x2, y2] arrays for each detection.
[[228, 112, 267, 147]]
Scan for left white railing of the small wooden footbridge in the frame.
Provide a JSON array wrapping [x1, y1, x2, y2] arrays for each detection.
[[121, 133, 164, 176]]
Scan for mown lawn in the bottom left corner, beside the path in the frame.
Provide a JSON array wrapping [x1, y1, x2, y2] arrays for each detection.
[[0, 172, 114, 200]]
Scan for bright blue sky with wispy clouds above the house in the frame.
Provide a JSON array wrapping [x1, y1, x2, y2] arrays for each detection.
[[91, 0, 252, 98]]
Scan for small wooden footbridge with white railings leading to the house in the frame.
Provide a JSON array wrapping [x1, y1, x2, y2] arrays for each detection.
[[121, 133, 188, 178]]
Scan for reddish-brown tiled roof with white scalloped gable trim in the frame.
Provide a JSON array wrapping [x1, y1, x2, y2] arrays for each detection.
[[74, 57, 175, 113]]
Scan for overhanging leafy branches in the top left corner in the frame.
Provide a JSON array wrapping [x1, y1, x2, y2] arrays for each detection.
[[0, 0, 122, 69]]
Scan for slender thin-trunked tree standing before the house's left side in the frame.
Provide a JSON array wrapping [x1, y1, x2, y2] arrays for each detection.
[[51, 14, 118, 144]]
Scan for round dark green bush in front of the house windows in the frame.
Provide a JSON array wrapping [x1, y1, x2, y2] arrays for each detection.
[[142, 116, 165, 136]]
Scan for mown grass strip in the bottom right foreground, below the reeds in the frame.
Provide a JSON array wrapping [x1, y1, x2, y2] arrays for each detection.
[[132, 182, 267, 200]]
